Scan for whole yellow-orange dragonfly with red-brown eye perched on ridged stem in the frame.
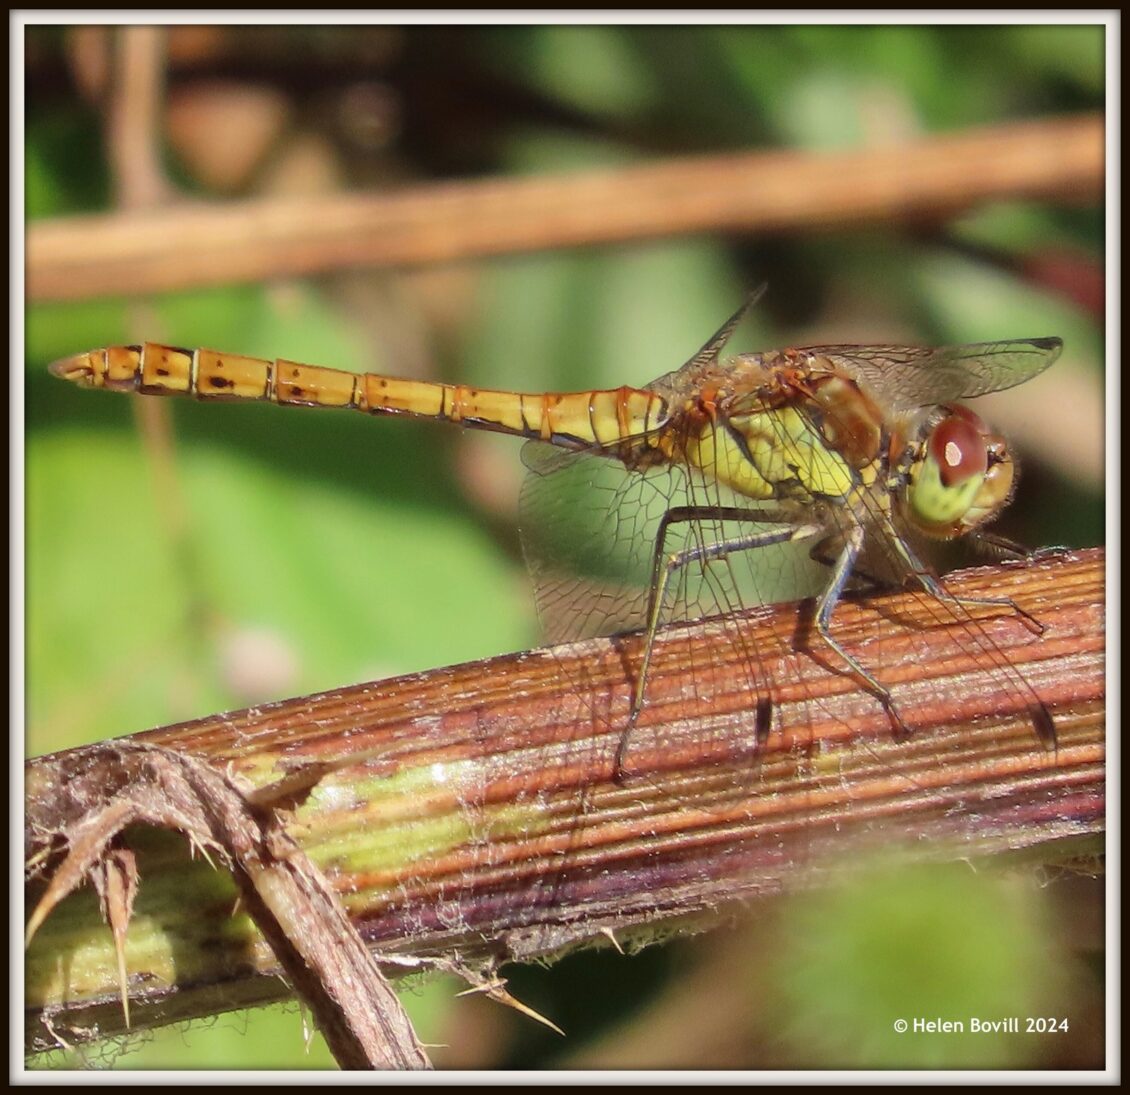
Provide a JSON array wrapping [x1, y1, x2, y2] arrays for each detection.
[[50, 294, 1062, 779]]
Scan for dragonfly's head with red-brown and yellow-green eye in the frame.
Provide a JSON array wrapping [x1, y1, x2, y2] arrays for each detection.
[[903, 403, 1016, 540]]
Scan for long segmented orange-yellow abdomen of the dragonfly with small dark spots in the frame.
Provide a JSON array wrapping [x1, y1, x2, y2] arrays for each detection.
[[51, 342, 668, 449]]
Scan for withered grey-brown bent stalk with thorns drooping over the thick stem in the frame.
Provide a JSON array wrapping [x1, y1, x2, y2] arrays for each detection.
[[27, 740, 429, 1069]]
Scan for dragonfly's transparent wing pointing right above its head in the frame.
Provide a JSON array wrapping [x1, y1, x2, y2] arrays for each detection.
[[801, 338, 1063, 411]]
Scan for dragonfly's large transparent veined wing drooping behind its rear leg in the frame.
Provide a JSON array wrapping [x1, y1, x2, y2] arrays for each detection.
[[520, 442, 826, 803]]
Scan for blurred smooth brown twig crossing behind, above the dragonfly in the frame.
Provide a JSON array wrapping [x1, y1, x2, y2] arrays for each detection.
[[27, 114, 1105, 301]]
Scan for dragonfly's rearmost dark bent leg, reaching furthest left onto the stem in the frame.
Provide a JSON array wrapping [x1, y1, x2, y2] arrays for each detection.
[[615, 506, 823, 781]]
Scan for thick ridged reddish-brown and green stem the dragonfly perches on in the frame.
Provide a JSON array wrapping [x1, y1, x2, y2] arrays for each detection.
[[27, 550, 1105, 1049]]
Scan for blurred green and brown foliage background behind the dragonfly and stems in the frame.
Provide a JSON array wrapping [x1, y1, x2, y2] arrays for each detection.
[[25, 25, 1104, 1068]]
